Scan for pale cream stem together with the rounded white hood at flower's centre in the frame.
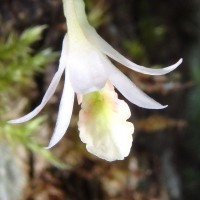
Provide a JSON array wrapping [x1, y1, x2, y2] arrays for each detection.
[[64, 0, 108, 94]]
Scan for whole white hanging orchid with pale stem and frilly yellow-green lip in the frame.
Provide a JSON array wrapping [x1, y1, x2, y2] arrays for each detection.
[[9, 0, 182, 161]]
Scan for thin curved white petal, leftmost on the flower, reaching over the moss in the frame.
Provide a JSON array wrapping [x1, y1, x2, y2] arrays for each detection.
[[8, 35, 68, 124]]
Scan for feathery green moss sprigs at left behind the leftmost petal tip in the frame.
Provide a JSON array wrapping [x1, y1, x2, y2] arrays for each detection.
[[0, 26, 62, 166]]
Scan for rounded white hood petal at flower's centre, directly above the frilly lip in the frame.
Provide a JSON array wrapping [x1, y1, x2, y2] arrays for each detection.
[[69, 44, 108, 94]]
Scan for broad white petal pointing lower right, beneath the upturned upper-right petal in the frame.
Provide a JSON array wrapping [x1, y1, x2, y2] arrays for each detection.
[[109, 64, 167, 109]]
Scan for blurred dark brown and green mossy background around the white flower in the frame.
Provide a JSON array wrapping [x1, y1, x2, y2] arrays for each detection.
[[0, 0, 200, 200]]
